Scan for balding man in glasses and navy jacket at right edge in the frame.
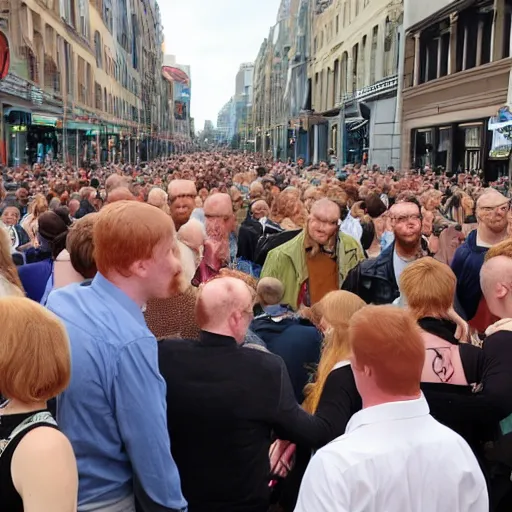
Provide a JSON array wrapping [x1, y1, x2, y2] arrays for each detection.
[[451, 189, 510, 333]]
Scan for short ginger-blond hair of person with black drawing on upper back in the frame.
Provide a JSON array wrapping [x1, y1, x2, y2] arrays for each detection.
[[400, 257, 457, 320]]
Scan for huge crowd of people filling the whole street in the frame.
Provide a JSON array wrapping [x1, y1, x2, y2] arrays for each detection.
[[0, 152, 512, 512]]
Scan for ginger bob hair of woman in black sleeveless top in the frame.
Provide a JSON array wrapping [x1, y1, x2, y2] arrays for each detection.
[[0, 297, 71, 404]]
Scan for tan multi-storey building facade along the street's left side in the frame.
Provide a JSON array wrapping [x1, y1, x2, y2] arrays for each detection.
[[0, 0, 169, 165]]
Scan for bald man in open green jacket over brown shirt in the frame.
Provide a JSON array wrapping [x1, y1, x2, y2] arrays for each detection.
[[261, 199, 364, 309]]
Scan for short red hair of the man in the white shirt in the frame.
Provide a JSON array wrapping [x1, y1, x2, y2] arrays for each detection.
[[349, 306, 425, 396]]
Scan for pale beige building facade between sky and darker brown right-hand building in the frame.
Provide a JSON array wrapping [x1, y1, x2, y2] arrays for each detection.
[[253, 0, 403, 167]]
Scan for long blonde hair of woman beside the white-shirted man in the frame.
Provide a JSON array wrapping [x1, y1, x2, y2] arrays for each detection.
[[303, 290, 366, 414]]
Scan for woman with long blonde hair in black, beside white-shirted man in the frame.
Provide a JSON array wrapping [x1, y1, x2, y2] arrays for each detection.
[[270, 291, 366, 511]]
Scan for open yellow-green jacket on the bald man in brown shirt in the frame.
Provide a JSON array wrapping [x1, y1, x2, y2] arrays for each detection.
[[261, 231, 364, 309]]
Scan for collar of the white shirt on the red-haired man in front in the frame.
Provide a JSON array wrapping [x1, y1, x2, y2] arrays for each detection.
[[346, 393, 430, 433]]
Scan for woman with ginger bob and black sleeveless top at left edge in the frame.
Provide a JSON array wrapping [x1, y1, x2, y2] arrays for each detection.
[[0, 297, 78, 512]]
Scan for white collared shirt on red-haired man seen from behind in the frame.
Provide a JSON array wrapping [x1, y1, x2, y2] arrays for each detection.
[[295, 396, 489, 512]]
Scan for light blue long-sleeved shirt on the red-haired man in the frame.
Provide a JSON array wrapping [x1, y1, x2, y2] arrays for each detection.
[[47, 274, 187, 510]]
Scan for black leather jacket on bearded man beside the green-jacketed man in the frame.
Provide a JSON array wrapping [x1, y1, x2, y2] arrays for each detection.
[[342, 243, 400, 305]]
